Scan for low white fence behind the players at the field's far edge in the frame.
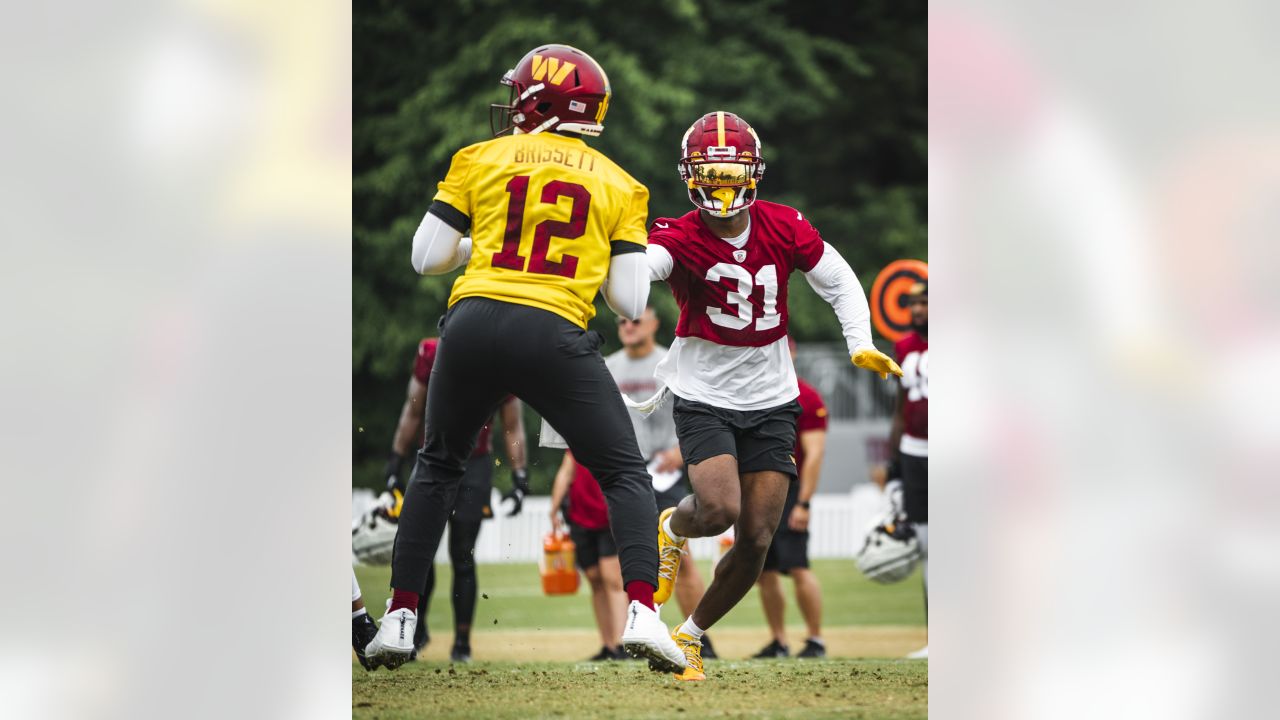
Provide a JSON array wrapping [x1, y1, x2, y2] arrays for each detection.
[[351, 483, 883, 562]]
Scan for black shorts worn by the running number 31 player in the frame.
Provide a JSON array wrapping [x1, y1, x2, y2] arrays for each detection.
[[673, 396, 800, 479]]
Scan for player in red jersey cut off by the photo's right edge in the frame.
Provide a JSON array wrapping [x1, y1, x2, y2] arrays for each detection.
[[888, 282, 929, 657]]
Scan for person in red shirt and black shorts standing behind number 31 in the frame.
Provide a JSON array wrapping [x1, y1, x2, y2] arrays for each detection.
[[755, 337, 827, 657]]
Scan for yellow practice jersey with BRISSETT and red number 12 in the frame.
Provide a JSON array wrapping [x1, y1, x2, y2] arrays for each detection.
[[435, 133, 649, 328]]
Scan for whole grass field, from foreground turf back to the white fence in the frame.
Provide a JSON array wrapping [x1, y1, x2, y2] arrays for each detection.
[[352, 560, 928, 719]]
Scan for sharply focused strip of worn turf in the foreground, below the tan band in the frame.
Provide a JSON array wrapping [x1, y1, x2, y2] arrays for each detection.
[[352, 660, 929, 720]]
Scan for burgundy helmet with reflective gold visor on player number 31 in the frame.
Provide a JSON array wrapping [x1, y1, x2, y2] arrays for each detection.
[[680, 110, 764, 218]]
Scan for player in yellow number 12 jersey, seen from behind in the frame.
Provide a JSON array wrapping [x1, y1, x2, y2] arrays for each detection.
[[365, 45, 686, 671]]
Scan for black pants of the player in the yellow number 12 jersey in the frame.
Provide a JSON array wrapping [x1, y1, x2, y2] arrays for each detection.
[[392, 297, 658, 592]]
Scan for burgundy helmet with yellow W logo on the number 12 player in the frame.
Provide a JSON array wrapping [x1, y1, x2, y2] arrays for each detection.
[[489, 45, 612, 136]]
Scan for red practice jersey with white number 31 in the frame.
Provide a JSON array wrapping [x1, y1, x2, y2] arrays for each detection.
[[649, 200, 823, 347]]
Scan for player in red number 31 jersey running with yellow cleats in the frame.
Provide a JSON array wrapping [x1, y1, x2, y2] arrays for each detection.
[[646, 111, 901, 680]]
